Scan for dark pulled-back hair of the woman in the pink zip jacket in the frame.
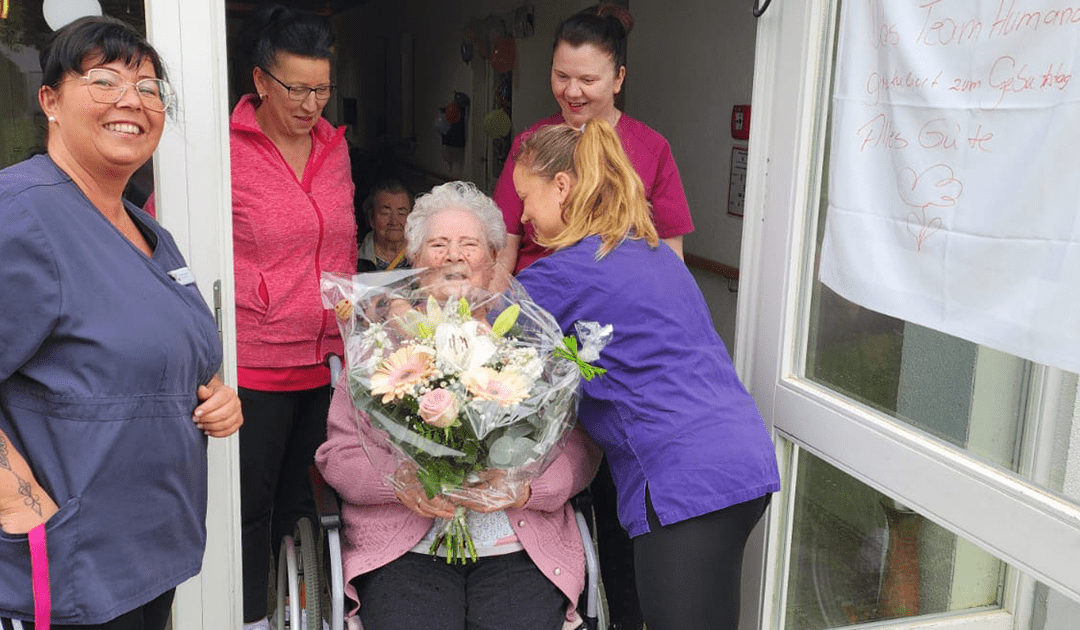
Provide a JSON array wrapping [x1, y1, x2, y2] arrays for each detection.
[[243, 4, 334, 69]]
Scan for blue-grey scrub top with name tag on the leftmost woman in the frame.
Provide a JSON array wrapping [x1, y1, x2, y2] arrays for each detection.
[[0, 156, 221, 625]]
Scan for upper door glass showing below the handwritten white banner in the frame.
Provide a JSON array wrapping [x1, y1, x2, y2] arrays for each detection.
[[804, 0, 1080, 499]]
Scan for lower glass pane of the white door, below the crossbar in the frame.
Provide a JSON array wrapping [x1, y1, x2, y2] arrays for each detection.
[[785, 451, 1004, 630]]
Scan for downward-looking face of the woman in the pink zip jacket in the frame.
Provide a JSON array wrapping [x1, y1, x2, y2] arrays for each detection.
[[252, 53, 330, 138]]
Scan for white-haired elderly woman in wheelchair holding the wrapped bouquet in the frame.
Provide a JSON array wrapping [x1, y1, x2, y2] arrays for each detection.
[[315, 182, 599, 630]]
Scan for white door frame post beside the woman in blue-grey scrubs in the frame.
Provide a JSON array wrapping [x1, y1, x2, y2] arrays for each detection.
[[146, 0, 243, 630]]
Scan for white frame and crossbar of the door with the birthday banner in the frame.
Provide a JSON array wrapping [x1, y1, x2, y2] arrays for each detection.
[[737, 0, 1080, 628]]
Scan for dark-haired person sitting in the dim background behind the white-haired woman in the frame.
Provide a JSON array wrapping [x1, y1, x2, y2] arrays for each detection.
[[356, 179, 413, 271]]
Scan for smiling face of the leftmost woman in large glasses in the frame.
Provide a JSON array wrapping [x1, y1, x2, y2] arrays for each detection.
[[38, 56, 165, 178]]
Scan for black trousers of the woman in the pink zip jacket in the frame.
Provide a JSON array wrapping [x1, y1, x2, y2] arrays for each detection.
[[238, 386, 330, 622]]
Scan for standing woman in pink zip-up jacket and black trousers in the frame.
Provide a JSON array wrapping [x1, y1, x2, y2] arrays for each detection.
[[230, 6, 356, 628]]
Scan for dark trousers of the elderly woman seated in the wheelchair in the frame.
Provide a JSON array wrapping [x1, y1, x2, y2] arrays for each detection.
[[352, 551, 568, 630]]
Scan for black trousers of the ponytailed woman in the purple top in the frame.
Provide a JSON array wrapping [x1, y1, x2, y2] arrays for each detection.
[[634, 491, 771, 630]]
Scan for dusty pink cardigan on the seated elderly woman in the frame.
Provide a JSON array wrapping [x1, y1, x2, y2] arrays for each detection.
[[315, 374, 602, 614]]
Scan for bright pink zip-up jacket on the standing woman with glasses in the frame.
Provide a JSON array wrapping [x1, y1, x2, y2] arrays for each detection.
[[229, 94, 356, 371]]
